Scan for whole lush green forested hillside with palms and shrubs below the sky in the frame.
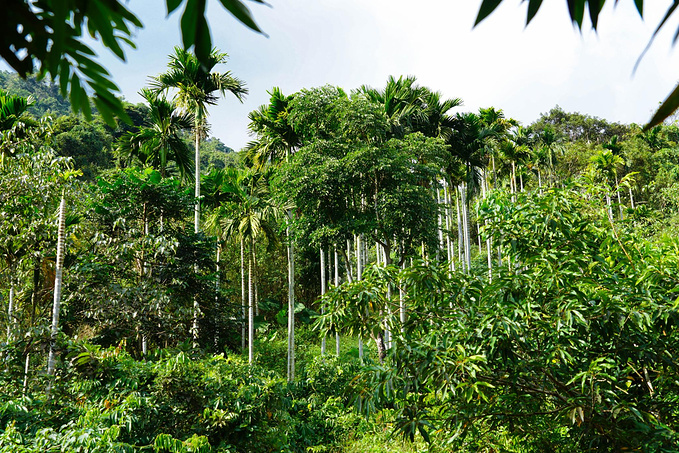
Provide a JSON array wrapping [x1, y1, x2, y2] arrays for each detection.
[[0, 64, 679, 452]]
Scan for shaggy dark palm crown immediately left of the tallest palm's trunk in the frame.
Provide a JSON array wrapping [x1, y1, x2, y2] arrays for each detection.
[[118, 88, 194, 179]]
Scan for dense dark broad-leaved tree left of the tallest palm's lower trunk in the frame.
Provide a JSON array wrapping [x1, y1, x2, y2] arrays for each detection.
[[67, 169, 234, 350]]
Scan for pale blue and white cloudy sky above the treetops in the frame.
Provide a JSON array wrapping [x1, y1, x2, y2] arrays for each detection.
[[18, 0, 679, 150]]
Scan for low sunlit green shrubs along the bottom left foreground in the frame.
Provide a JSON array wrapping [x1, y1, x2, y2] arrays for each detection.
[[0, 342, 370, 453]]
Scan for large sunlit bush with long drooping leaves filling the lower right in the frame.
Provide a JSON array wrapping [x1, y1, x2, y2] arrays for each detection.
[[321, 188, 679, 451]]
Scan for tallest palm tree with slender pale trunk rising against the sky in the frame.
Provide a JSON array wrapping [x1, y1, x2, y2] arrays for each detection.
[[151, 47, 248, 233]]
